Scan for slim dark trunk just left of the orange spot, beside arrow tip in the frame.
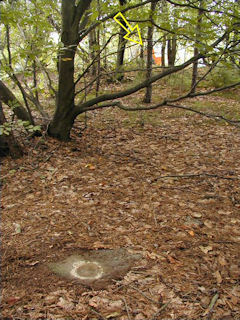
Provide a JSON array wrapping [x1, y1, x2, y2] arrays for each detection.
[[143, 0, 157, 103]]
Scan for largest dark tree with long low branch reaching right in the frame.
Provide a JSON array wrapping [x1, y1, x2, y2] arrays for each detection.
[[48, 0, 230, 141]]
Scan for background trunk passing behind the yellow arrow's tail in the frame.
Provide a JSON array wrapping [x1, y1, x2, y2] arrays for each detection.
[[116, 0, 127, 81]]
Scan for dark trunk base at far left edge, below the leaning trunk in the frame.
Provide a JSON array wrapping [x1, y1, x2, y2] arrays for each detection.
[[0, 102, 23, 159]]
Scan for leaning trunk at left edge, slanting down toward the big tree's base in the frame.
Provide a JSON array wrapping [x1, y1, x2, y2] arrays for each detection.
[[0, 80, 32, 124]]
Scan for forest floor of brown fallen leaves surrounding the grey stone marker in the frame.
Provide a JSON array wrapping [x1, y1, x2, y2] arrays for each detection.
[[2, 85, 240, 320]]
